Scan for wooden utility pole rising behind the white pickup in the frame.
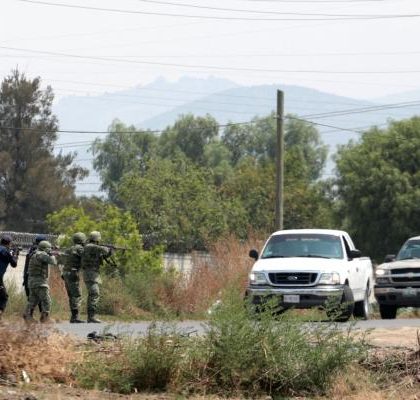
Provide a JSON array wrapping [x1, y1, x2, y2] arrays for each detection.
[[276, 90, 284, 230]]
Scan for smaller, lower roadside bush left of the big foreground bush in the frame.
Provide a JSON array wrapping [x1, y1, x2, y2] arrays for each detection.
[[76, 323, 189, 393]]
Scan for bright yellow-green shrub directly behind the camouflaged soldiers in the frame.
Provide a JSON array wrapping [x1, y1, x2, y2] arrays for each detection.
[[47, 201, 163, 276]]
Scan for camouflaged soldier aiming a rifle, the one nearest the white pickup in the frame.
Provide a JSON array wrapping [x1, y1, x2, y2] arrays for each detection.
[[82, 231, 112, 323]]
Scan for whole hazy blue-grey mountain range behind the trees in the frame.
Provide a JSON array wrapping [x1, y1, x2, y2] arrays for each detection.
[[54, 77, 420, 194]]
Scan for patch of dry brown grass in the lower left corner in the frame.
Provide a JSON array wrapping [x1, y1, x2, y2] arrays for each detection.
[[0, 323, 79, 383]]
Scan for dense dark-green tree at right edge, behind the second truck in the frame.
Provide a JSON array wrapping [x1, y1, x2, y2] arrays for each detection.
[[336, 117, 420, 260]]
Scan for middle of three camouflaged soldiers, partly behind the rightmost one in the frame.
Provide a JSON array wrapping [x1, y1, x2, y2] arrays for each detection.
[[62, 232, 86, 323]]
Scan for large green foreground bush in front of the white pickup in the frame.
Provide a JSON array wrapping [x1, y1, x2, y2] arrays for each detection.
[[188, 293, 368, 395]]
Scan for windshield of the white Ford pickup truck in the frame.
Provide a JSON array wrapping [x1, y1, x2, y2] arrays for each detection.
[[261, 234, 343, 258]]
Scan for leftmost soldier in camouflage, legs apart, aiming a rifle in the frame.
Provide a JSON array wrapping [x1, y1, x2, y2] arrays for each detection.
[[23, 240, 57, 322]]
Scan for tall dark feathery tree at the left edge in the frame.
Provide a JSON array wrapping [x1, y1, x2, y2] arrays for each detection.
[[0, 70, 87, 231]]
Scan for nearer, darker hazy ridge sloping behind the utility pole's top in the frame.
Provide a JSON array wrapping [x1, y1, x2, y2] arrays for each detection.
[[136, 85, 413, 152]]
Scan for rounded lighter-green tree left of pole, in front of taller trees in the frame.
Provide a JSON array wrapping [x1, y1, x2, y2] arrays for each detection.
[[119, 157, 240, 252]]
